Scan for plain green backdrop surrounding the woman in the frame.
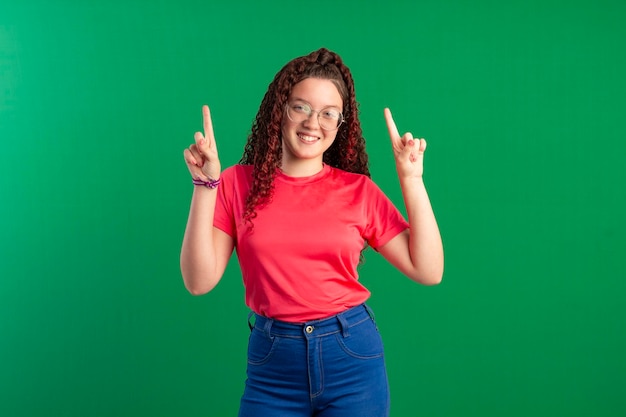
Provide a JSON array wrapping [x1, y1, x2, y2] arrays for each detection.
[[0, 0, 626, 417]]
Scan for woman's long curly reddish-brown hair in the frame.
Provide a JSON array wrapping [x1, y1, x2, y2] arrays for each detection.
[[239, 48, 370, 223]]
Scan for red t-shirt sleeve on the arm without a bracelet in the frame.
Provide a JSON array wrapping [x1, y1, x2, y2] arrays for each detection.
[[364, 180, 409, 249]]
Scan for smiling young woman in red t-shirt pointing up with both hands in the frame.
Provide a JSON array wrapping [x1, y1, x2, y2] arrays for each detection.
[[181, 48, 443, 417]]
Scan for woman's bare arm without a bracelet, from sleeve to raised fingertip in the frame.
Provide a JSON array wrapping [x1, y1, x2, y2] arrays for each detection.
[[378, 109, 443, 285]]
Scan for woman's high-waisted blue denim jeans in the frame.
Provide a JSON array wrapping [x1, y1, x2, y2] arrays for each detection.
[[239, 305, 389, 417]]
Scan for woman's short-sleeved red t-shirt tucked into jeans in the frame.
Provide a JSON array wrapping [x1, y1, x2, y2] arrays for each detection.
[[214, 165, 409, 323]]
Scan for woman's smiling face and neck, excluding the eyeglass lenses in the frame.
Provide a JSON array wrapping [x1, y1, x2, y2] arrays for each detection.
[[281, 78, 343, 176]]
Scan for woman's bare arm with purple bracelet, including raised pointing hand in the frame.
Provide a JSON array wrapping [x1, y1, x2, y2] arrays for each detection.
[[180, 106, 234, 295]]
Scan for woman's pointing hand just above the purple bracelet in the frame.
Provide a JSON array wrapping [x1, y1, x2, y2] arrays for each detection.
[[183, 105, 221, 181]]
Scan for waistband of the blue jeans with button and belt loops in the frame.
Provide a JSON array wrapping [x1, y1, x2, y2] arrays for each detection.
[[248, 304, 374, 337]]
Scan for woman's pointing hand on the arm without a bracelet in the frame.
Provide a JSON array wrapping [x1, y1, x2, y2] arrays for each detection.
[[385, 109, 426, 178]]
